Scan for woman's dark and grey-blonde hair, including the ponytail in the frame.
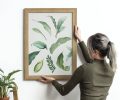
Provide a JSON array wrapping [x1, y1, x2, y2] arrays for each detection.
[[87, 33, 116, 71]]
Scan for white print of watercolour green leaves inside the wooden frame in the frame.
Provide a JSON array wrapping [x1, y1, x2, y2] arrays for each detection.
[[28, 13, 72, 75]]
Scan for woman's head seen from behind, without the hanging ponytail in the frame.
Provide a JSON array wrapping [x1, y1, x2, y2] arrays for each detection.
[[87, 33, 109, 58]]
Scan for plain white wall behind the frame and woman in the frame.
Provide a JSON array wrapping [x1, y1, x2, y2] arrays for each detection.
[[0, 0, 120, 100]]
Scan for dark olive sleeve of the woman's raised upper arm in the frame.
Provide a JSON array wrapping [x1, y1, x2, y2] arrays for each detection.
[[78, 41, 92, 63]]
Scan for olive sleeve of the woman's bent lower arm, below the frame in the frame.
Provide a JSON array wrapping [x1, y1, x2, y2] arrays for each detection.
[[52, 66, 84, 96]]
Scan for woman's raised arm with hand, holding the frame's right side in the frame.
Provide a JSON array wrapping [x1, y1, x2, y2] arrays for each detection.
[[75, 26, 92, 63]]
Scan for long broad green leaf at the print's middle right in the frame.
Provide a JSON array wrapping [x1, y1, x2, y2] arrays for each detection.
[[50, 37, 71, 54]]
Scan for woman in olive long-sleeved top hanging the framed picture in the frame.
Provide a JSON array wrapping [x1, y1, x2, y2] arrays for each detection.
[[40, 26, 116, 100]]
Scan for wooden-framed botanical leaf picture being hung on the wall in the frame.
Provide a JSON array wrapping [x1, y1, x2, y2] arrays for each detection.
[[23, 8, 77, 80]]
